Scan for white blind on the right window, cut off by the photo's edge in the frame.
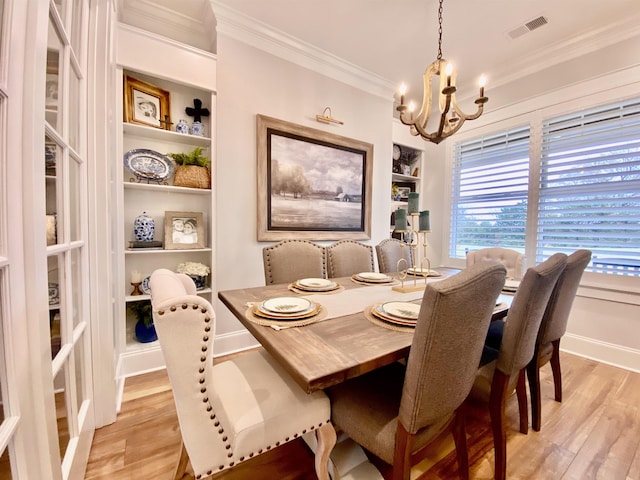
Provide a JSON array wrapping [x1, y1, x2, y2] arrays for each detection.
[[536, 99, 640, 276]]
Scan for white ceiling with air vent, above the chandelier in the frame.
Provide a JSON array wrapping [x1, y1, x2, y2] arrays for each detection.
[[120, 0, 640, 100]]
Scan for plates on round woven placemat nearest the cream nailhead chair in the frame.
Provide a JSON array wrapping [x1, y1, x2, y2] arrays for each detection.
[[246, 297, 326, 329]]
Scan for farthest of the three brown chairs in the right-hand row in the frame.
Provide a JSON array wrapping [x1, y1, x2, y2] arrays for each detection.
[[527, 250, 591, 431]]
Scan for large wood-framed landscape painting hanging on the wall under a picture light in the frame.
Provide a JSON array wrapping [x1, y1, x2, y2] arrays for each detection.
[[256, 114, 373, 241]]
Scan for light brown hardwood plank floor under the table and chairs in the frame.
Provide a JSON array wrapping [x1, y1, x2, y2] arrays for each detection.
[[85, 353, 640, 480]]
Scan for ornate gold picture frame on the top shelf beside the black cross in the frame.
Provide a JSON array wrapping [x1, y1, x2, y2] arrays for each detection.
[[124, 75, 171, 130]]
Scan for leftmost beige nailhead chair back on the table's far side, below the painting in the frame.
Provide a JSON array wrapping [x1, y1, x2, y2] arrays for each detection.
[[262, 240, 327, 285]]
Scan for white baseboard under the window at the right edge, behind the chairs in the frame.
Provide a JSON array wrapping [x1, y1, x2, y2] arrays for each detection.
[[560, 333, 640, 373]]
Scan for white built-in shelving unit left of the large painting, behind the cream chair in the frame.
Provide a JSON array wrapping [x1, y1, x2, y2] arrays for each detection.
[[114, 27, 216, 379]]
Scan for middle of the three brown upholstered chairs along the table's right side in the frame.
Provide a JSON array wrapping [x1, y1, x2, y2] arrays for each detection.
[[472, 253, 567, 480]]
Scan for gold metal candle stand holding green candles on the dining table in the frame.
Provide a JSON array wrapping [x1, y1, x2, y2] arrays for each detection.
[[392, 213, 431, 293]]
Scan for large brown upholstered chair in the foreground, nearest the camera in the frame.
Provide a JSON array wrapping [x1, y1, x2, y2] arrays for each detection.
[[327, 262, 506, 480]]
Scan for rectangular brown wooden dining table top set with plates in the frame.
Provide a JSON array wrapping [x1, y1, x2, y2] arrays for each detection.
[[218, 268, 512, 392]]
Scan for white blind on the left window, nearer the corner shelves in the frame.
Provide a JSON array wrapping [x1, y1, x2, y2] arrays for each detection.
[[449, 125, 530, 258]]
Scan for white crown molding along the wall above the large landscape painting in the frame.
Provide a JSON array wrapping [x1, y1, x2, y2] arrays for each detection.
[[211, 0, 395, 100]]
